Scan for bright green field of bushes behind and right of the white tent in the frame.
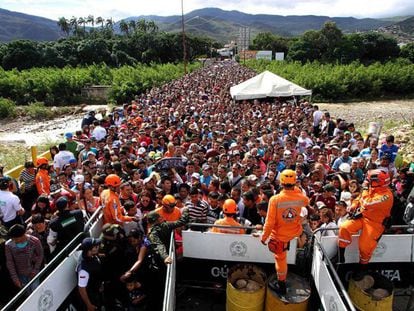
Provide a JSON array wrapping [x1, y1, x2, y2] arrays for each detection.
[[246, 59, 414, 101]]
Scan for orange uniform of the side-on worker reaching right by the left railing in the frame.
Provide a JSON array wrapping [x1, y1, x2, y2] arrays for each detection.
[[100, 189, 134, 225]]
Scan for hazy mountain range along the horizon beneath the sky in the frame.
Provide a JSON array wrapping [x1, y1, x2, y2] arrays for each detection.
[[0, 8, 410, 43]]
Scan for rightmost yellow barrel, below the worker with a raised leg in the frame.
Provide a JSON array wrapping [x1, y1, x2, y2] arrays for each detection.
[[348, 272, 394, 311]]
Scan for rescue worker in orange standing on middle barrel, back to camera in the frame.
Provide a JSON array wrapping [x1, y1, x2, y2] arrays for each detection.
[[261, 170, 309, 295]]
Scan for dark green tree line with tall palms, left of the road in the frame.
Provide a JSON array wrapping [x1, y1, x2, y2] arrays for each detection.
[[0, 15, 217, 70]]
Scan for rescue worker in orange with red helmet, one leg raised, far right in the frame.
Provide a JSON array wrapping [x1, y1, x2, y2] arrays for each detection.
[[338, 169, 394, 279]]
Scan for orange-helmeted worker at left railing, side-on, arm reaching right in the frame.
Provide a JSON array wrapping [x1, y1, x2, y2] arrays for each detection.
[[100, 174, 137, 225]]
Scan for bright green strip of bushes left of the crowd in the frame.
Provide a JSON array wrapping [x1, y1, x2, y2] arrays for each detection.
[[0, 63, 200, 108]]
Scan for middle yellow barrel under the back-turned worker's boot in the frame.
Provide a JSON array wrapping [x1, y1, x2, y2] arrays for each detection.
[[265, 272, 311, 311]]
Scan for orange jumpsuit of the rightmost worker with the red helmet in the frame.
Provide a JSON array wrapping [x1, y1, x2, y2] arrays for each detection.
[[338, 187, 394, 264]]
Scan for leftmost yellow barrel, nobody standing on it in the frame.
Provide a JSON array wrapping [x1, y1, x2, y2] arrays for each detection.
[[226, 264, 266, 311]]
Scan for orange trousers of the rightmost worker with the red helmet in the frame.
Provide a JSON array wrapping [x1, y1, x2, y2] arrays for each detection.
[[338, 217, 384, 264]]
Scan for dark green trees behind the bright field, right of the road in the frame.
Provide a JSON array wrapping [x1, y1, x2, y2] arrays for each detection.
[[250, 21, 414, 65]]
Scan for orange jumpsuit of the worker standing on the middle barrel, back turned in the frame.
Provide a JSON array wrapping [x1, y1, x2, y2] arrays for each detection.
[[262, 187, 309, 281]]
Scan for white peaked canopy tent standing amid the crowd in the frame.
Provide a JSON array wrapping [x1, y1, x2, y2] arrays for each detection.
[[230, 71, 312, 100]]
